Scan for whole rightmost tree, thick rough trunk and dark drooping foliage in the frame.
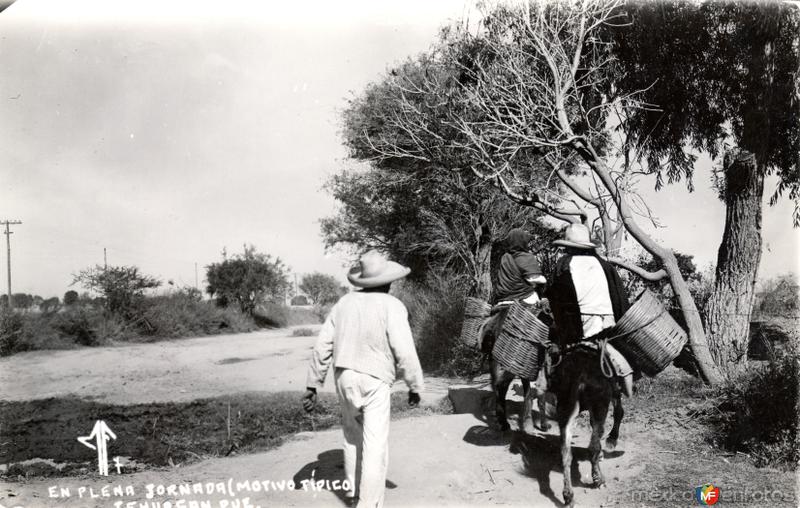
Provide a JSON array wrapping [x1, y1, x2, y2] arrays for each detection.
[[611, 1, 800, 369]]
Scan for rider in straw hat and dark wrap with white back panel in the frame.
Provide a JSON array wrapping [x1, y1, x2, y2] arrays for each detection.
[[546, 224, 633, 396]]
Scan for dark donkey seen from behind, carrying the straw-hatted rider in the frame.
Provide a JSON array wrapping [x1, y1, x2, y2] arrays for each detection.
[[551, 342, 624, 507]]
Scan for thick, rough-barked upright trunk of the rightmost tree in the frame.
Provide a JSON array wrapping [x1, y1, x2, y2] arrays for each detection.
[[706, 150, 764, 372]]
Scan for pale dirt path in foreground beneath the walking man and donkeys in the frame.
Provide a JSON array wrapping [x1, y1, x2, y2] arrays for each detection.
[[0, 414, 642, 508]]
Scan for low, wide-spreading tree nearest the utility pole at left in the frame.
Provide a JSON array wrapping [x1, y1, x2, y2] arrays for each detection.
[[73, 265, 161, 318]]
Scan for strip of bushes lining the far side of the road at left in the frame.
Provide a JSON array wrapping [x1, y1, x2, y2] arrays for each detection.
[[0, 246, 321, 356]]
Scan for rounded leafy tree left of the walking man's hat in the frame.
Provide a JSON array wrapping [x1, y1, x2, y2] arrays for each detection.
[[206, 245, 289, 315]]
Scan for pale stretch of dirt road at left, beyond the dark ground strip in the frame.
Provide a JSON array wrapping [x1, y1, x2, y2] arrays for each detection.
[[0, 326, 448, 404]]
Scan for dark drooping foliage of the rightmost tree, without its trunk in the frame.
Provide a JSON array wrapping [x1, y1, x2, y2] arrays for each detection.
[[608, 1, 800, 218]]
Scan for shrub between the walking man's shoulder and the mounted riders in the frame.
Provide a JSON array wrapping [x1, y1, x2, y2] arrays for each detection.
[[393, 276, 482, 376]]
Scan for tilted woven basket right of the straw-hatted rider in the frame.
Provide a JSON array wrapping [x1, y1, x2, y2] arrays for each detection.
[[611, 290, 686, 376]]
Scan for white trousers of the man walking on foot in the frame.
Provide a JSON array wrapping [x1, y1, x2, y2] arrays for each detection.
[[334, 369, 391, 508]]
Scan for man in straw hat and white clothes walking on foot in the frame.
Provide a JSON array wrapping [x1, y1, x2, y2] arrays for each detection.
[[303, 251, 423, 508]]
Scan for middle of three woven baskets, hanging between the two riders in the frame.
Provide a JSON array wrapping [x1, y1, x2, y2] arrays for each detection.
[[492, 303, 550, 379]]
